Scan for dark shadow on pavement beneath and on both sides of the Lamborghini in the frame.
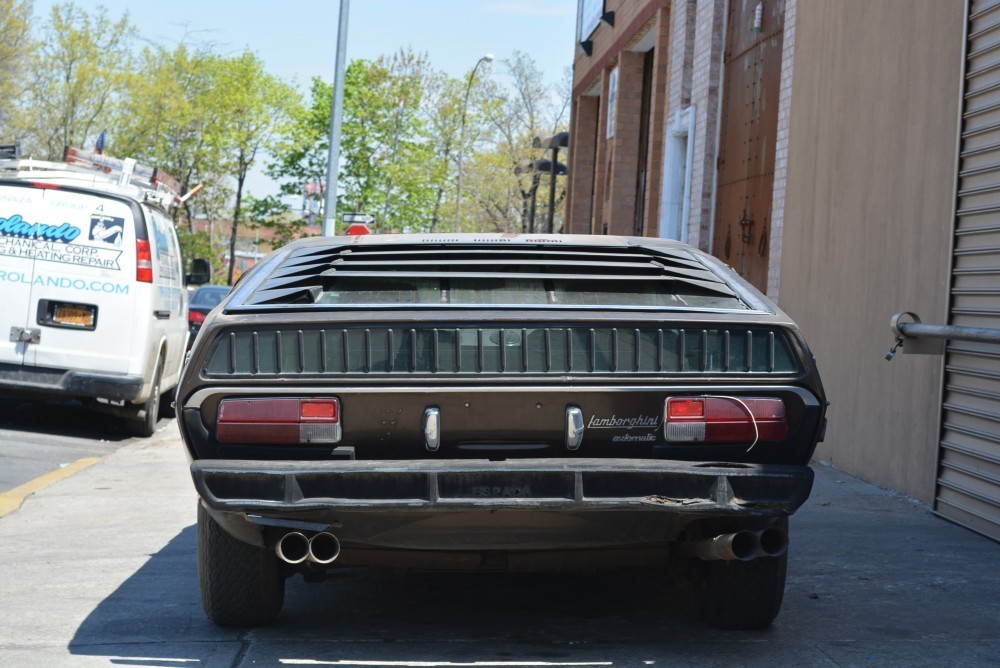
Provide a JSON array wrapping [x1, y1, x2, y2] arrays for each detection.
[[69, 471, 1000, 668]]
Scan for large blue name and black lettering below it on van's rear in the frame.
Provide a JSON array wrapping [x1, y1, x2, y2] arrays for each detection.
[[0, 214, 124, 271]]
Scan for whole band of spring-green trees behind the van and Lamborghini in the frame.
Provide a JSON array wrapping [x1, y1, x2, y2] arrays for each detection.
[[0, 8, 569, 258]]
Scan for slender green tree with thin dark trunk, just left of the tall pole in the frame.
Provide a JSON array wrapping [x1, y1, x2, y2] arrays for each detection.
[[214, 51, 297, 285]]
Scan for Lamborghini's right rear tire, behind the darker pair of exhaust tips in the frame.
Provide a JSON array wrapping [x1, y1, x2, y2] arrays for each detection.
[[704, 524, 788, 630]]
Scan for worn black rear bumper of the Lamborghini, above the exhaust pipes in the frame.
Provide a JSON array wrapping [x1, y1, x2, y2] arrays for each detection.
[[191, 458, 813, 517]]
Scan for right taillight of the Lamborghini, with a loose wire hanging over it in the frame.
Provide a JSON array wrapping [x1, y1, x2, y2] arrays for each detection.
[[663, 397, 788, 447]]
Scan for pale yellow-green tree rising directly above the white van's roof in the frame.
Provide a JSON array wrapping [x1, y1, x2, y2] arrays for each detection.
[[15, 3, 135, 160]]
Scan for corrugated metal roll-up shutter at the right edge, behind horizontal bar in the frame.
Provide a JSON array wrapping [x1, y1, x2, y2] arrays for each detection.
[[935, 0, 1000, 540]]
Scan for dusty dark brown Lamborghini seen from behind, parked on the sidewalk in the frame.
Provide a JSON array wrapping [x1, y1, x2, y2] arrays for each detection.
[[177, 234, 826, 628]]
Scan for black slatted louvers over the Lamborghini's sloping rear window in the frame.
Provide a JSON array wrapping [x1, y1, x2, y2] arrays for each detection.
[[242, 243, 739, 307]]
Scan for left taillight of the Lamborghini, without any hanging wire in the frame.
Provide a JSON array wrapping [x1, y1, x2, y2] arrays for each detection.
[[215, 397, 340, 443]]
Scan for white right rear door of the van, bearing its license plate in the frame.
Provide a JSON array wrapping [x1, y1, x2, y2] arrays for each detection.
[[0, 187, 139, 374]]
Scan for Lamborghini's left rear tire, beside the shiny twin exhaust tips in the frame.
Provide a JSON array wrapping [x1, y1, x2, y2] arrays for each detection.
[[198, 503, 285, 627]]
